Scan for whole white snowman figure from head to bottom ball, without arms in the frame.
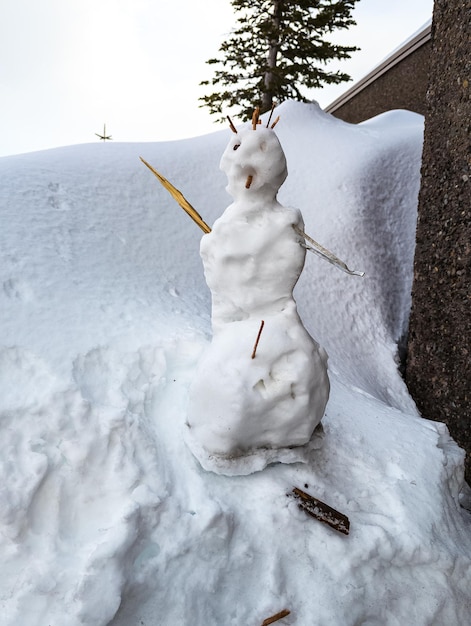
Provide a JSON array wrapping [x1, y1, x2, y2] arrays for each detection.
[[188, 120, 329, 458]]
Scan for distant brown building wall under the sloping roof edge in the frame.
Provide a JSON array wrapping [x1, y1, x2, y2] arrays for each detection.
[[332, 41, 430, 124]]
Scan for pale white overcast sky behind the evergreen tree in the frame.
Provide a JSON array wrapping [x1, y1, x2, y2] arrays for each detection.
[[0, 0, 433, 156]]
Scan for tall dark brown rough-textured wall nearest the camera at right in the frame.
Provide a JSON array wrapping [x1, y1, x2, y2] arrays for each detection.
[[406, 0, 471, 482]]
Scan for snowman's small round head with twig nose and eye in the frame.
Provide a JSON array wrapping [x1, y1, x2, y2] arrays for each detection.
[[220, 124, 288, 200]]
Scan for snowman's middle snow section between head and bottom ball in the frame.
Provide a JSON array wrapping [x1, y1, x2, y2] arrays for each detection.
[[200, 202, 305, 331]]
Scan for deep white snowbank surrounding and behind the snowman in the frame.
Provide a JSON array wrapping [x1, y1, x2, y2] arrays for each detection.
[[0, 102, 471, 626]]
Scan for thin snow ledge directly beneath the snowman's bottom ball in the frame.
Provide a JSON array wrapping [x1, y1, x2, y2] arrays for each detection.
[[185, 424, 324, 476]]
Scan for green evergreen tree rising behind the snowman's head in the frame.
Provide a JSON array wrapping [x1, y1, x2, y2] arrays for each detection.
[[200, 0, 358, 119]]
